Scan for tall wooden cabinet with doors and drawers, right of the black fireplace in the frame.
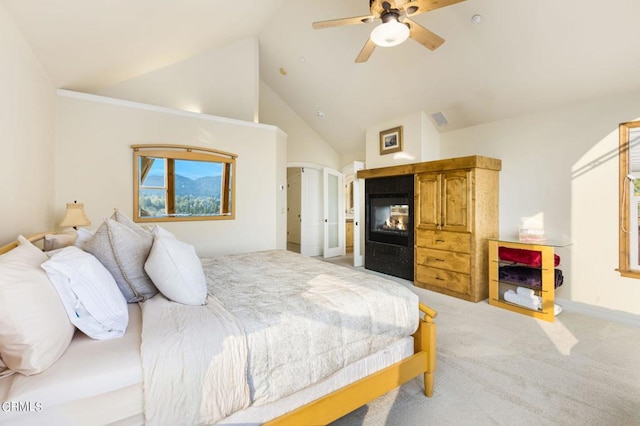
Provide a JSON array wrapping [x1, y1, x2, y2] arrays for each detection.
[[414, 156, 501, 302]]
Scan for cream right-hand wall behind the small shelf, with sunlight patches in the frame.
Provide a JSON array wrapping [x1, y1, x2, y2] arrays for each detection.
[[441, 93, 640, 315]]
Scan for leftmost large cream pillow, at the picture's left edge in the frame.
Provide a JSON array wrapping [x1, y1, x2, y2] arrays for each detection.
[[0, 235, 75, 376]]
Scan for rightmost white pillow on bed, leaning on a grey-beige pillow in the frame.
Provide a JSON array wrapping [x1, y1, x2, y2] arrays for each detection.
[[144, 233, 207, 305]]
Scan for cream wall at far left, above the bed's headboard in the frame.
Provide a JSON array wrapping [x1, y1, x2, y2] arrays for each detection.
[[0, 3, 55, 245]]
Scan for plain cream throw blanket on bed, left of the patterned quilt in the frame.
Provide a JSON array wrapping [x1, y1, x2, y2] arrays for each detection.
[[140, 294, 250, 426]]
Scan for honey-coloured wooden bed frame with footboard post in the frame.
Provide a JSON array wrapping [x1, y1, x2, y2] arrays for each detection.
[[0, 232, 438, 426]]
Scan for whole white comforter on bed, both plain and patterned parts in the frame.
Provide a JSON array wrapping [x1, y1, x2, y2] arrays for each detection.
[[141, 250, 418, 424]]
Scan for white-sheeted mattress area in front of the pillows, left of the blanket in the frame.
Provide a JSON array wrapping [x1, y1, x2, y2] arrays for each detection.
[[0, 304, 143, 426]]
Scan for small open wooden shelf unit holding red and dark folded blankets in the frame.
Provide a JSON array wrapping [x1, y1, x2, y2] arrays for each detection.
[[489, 240, 556, 322]]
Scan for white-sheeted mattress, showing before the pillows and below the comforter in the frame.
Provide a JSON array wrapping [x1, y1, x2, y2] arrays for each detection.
[[0, 298, 413, 426]]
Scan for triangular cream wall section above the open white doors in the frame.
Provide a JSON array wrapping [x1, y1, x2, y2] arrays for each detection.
[[260, 81, 340, 170]]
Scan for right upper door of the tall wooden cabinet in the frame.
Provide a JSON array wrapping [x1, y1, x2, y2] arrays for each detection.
[[440, 170, 471, 232]]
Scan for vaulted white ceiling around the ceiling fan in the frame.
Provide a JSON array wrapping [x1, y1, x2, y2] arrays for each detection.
[[2, 0, 640, 153]]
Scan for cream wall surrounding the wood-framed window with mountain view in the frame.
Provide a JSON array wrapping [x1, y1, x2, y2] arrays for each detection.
[[53, 91, 286, 256]]
